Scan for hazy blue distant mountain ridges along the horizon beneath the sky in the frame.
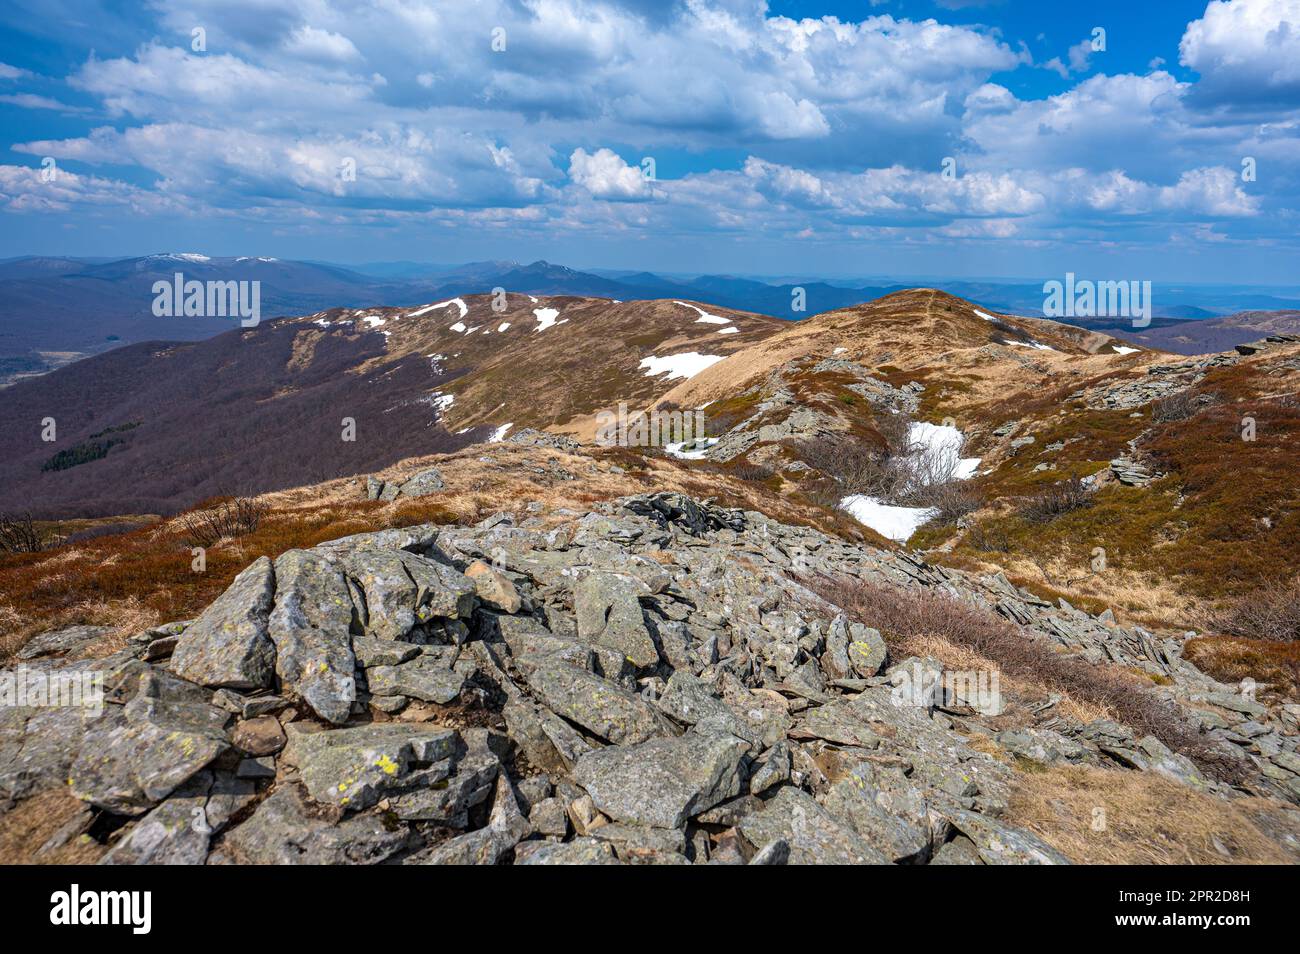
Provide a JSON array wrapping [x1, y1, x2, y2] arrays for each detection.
[[0, 252, 1300, 385]]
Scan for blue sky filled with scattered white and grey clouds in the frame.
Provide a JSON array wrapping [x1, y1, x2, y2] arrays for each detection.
[[0, 0, 1300, 285]]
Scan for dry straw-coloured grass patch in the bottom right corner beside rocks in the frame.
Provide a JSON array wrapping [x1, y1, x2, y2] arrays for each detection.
[[1005, 766, 1297, 864]]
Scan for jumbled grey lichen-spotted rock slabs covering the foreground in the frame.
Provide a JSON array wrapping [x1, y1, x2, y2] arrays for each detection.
[[0, 494, 1300, 864]]
